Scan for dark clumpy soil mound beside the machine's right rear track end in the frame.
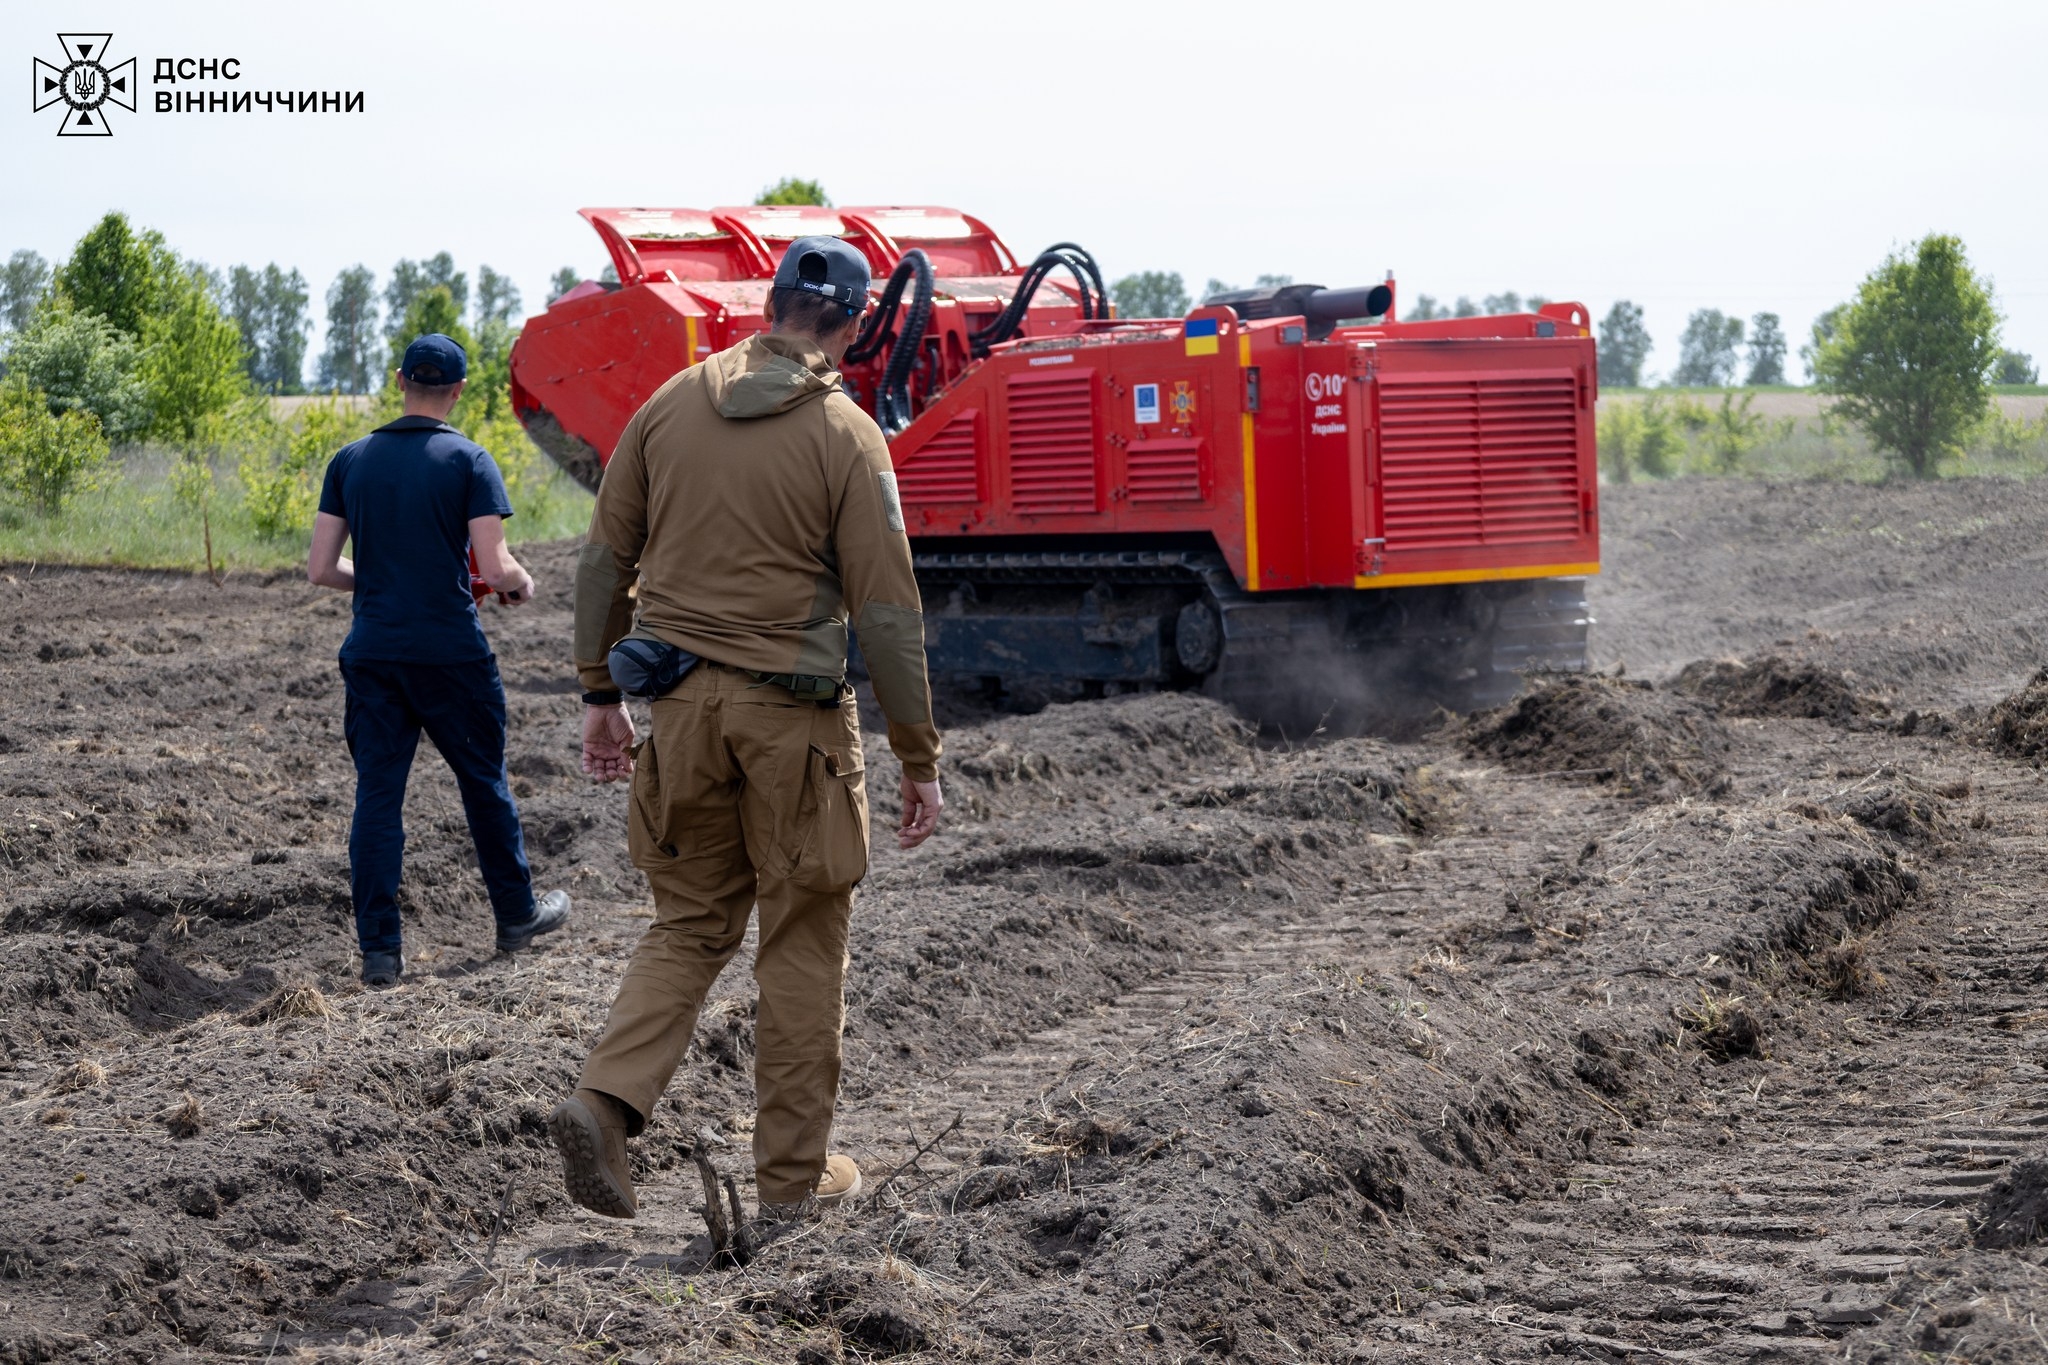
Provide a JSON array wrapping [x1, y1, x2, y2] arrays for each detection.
[[1462, 673, 1731, 794]]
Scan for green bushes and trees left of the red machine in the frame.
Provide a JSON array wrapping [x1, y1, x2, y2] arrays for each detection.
[[0, 213, 593, 536]]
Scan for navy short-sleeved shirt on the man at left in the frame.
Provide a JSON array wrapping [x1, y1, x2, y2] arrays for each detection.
[[319, 417, 512, 663]]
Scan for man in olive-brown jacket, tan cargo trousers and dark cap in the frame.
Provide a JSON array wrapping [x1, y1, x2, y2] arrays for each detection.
[[549, 237, 940, 1218]]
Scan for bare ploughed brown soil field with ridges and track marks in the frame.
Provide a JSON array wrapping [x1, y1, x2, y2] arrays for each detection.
[[0, 472, 2048, 1365]]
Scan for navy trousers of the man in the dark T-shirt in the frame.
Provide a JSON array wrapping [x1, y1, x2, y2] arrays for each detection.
[[342, 657, 535, 954]]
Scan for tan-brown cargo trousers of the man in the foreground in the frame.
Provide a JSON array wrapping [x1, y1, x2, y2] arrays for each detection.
[[582, 663, 868, 1203]]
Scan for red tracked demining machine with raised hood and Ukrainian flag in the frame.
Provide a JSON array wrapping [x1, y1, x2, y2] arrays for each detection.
[[512, 207, 1599, 729]]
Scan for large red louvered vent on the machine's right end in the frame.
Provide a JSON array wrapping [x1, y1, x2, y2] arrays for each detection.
[[1380, 375, 1579, 551]]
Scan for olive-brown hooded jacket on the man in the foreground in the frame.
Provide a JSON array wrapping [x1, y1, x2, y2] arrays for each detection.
[[575, 334, 940, 782]]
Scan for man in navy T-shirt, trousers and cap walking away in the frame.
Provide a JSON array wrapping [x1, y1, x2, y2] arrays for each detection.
[[307, 334, 569, 986]]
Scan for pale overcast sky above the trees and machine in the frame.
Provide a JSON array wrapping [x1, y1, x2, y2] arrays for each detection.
[[0, 0, 2048, 372]]
